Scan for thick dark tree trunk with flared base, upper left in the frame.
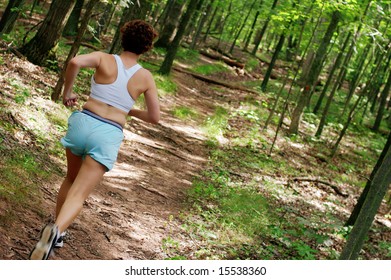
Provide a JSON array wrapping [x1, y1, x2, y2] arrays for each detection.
[[19, 0, 75, 66]]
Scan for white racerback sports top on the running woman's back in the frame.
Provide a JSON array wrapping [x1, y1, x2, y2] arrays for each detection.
[[91, 55, 142, 113]]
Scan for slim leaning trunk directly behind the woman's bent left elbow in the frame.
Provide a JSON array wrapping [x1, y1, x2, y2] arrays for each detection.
[[51, 0, 100, 101]]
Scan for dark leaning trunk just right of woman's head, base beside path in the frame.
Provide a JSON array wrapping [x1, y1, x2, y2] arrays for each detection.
[[159, 0, 198, 75]]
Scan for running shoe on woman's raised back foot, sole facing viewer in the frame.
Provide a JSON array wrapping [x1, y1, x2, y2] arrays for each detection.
[[30, 225, 57, 260]]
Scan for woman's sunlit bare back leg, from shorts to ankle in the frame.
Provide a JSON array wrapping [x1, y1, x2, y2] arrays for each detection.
[[56, 156, 106, 232]]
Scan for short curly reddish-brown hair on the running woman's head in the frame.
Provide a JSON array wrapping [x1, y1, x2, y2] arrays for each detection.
[[121, 19, 158, 54]]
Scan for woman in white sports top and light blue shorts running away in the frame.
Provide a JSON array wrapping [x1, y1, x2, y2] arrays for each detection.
[[29, 20, 160, 260]]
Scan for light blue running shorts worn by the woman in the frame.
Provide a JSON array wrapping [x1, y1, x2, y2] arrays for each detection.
[[61, 111, 124, 171]]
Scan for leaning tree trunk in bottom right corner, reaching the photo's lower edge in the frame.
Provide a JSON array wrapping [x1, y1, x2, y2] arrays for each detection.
[[340, 134, 391, 260]]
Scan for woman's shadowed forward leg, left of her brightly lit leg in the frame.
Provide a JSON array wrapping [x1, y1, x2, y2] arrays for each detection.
[[56, 148, 83, 217]]
